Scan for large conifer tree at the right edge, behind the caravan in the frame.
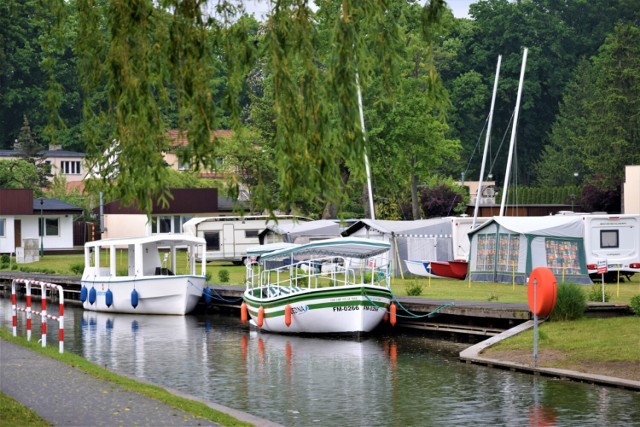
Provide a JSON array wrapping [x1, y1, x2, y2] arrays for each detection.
[[538, 24, 640, 195]]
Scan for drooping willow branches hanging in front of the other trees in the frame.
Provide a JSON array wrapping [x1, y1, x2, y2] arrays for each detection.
[[71, 0, 444, 212]]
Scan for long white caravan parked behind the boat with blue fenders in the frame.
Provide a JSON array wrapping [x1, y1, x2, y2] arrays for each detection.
[[183, 215, 309, 265]]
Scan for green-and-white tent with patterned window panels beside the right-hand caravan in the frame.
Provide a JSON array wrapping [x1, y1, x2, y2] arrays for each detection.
[[469, 216, 592, 284]]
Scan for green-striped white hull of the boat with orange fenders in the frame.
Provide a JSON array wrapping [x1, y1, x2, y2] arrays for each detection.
[[244, 286, 392, 334]]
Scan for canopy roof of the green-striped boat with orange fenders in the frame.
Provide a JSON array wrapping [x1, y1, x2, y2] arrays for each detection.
[[255, 237, 391, 260]]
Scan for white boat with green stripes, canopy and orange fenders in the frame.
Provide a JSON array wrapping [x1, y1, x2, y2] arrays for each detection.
[[243, 238, 392, 334]]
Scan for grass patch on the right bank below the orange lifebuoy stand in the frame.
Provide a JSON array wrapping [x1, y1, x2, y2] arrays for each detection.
[[486, 316, 640, 368]]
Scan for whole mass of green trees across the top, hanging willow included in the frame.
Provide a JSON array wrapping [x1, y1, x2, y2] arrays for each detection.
[[0, 0, 640, 218]]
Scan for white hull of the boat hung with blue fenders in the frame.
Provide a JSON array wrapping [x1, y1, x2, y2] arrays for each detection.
[[81, 276, 206, 315]]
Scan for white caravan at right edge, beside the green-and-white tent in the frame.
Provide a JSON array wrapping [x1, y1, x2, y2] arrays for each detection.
[[582, 214, 640, 281]]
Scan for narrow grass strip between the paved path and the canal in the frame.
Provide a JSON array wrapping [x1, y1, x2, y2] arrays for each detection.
[[0, 328, 252, 426]]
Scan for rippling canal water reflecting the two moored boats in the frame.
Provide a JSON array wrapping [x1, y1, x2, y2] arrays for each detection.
[[0, 298, 640, 426]]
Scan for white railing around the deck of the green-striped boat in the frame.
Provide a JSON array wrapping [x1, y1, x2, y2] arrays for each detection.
[[246, 256, 390, 290]]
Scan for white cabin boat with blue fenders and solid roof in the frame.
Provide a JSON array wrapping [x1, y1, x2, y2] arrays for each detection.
[[80, 234, 206, 315]]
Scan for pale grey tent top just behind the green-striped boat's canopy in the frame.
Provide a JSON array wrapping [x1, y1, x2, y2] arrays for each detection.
[[258, 219, 341, 245]]
